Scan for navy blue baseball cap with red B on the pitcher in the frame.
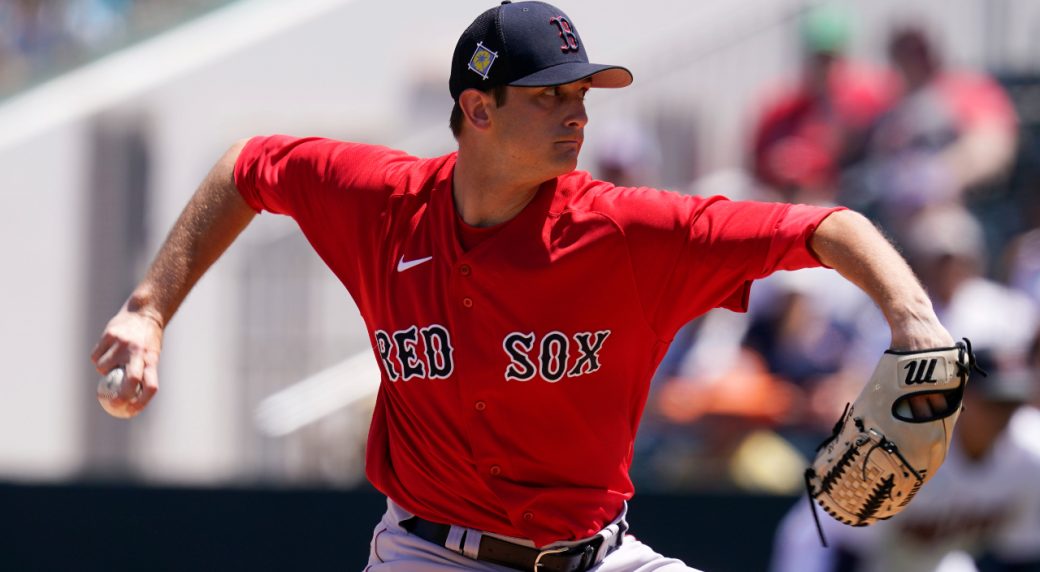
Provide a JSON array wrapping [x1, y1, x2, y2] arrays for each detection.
[[448, 1, 632, 101]]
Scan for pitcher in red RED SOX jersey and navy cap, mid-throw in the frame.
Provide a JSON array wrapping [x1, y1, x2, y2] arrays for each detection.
[[93, 2, 953, 572]]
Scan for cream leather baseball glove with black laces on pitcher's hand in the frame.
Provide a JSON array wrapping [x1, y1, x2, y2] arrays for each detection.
[[805, 338, 985, 544]]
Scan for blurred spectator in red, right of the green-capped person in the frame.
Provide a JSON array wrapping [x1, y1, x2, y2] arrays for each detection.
[[841, 27, 1017, 240]]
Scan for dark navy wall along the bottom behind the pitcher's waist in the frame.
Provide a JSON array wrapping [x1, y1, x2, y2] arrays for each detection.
[[0, 485, 794, 572]]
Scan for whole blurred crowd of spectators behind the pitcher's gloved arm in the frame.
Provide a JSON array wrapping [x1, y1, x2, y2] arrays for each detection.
[[615, 4, 1040, 572]]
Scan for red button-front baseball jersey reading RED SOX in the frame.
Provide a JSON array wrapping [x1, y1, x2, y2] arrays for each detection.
[[235, 136, 833, 546]]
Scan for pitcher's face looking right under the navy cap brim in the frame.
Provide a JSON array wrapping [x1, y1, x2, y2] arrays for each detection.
[[490, 79, 592, 181]]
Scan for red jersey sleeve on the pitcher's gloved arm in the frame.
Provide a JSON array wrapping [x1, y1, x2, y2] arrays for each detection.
[[615, 188, 841, 339]]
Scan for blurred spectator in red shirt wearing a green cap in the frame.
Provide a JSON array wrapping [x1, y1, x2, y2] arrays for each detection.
[[751, 4, 895, 203]]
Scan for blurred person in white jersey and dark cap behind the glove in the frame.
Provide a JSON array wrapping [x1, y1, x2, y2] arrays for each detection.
[[772, 349, 1040, 572]]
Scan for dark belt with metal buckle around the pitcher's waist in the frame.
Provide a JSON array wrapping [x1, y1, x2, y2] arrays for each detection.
[[400, 517, 628, 572]]
